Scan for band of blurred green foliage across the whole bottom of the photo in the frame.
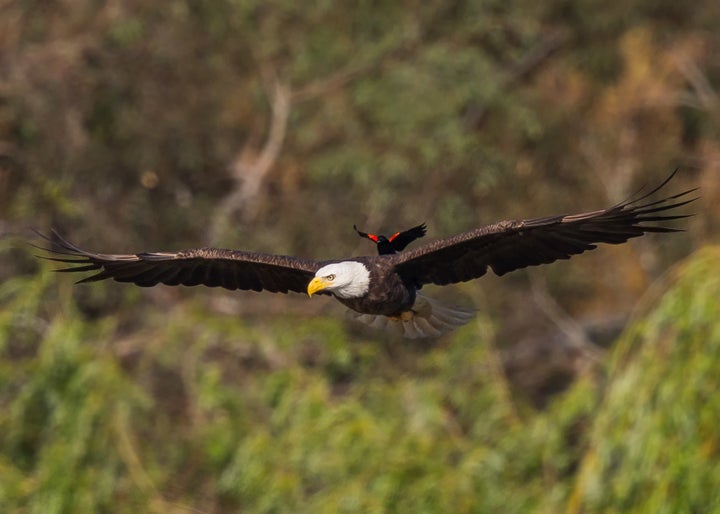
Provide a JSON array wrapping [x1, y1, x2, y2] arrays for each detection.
[[0, 242, 720, 513]]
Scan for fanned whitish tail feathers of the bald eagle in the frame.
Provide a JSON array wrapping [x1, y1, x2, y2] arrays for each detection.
[[348, 293, 475, 339]]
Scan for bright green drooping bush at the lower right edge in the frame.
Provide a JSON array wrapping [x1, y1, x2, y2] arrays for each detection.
[[570, 247, 720, 513]]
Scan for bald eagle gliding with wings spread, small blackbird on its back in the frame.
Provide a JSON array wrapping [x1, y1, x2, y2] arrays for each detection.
[[36, 170, 696, 338]]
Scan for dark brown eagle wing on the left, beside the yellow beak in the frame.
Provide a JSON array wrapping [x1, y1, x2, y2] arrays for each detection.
[[38, 231, 321, 293]]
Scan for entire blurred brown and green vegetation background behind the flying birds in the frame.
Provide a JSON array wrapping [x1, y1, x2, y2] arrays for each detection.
[[0, 0, 720, 513]]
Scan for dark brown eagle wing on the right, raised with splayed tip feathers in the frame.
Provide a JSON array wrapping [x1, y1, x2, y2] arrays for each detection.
[[393, 170, 697, 286]]
